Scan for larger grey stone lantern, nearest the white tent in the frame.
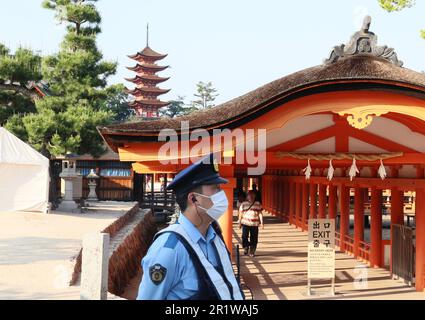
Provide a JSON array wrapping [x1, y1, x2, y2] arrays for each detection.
[[58, 155, 79, 212]]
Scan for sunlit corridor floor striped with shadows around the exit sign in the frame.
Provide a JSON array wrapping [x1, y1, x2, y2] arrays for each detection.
[[233, 212, 425, 300]]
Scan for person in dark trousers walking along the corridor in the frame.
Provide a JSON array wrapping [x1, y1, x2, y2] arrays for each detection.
[[238, 190, 264, 257]]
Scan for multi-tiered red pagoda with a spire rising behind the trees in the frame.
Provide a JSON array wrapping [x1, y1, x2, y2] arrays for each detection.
[[126, 24, 170, 118]]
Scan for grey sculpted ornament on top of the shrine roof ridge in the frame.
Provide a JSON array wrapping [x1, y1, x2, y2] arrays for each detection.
[[325, 16, 403, 67]]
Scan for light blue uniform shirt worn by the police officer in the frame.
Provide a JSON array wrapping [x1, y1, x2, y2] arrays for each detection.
[[137, 214, 219, 300]]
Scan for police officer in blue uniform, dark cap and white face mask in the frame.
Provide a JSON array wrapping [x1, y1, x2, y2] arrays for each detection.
[[137, 154, 244, 300]]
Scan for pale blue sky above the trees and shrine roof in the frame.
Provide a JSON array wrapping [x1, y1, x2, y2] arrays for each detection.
[[0, 0, 425, 103]]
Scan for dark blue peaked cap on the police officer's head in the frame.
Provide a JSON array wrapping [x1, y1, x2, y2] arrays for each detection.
[[166, 153, 228, 194]]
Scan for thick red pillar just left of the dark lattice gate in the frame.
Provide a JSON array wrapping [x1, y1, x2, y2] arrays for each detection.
[[370, 187, 382, 268]]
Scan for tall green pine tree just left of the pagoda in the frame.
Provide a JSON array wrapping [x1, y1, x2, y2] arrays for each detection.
[[0, 0, 117, 157]]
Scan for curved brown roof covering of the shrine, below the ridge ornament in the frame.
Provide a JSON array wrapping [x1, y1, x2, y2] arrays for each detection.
[[99, 55, 425, 135]]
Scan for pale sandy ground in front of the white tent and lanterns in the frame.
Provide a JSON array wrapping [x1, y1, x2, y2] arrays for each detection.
[[0, 202, 134, 299]]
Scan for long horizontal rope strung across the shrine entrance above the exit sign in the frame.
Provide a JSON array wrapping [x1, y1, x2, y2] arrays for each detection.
[[275, 151, 403, 161]]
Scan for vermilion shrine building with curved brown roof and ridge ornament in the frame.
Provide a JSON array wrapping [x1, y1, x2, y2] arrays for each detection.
[[99, 20, 425, 291]]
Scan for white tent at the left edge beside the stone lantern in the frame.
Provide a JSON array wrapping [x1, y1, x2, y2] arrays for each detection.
[[0, 127, 50, 212]]
